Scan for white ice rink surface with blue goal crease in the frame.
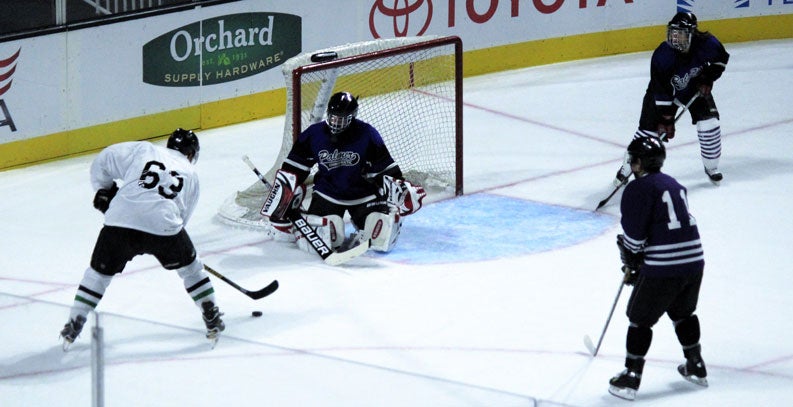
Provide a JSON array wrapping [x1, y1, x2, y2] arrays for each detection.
[[0, 40, 793, 407]]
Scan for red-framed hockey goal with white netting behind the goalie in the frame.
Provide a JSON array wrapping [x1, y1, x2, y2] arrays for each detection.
[[218, 36, 463, 228]]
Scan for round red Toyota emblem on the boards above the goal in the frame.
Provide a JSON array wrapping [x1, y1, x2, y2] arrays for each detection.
[[369, 0, 432, 38]]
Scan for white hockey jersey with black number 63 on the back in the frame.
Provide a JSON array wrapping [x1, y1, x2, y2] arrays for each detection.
[[91, 141, 199, 236]]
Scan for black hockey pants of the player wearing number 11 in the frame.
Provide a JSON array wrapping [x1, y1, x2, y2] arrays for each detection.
[[626, 271, 703, 328]]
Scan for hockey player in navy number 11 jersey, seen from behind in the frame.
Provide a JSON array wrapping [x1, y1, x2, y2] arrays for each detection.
[[609, 137, 708, 400]]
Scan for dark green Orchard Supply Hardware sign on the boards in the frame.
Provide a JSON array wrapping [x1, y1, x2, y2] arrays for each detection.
[[143, 13, 302, 86]]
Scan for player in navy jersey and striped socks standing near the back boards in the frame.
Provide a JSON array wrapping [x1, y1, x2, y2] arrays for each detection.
[[614, 12, 730, 187]]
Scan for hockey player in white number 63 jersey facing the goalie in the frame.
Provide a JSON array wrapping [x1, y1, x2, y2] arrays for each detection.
[[61, 128, 225, 350]]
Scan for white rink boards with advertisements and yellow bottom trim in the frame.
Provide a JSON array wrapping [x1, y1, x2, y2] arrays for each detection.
[[0, 0, 793, 169]]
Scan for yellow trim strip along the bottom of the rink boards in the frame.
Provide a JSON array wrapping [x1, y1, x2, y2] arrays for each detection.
[[0, 14, 793, 170]]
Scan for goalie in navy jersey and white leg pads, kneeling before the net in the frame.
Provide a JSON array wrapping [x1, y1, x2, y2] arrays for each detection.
[[262, 92, 426, 252]]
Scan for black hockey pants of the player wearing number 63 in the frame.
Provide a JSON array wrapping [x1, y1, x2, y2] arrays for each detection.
[[91, 226, 196, 276]]
